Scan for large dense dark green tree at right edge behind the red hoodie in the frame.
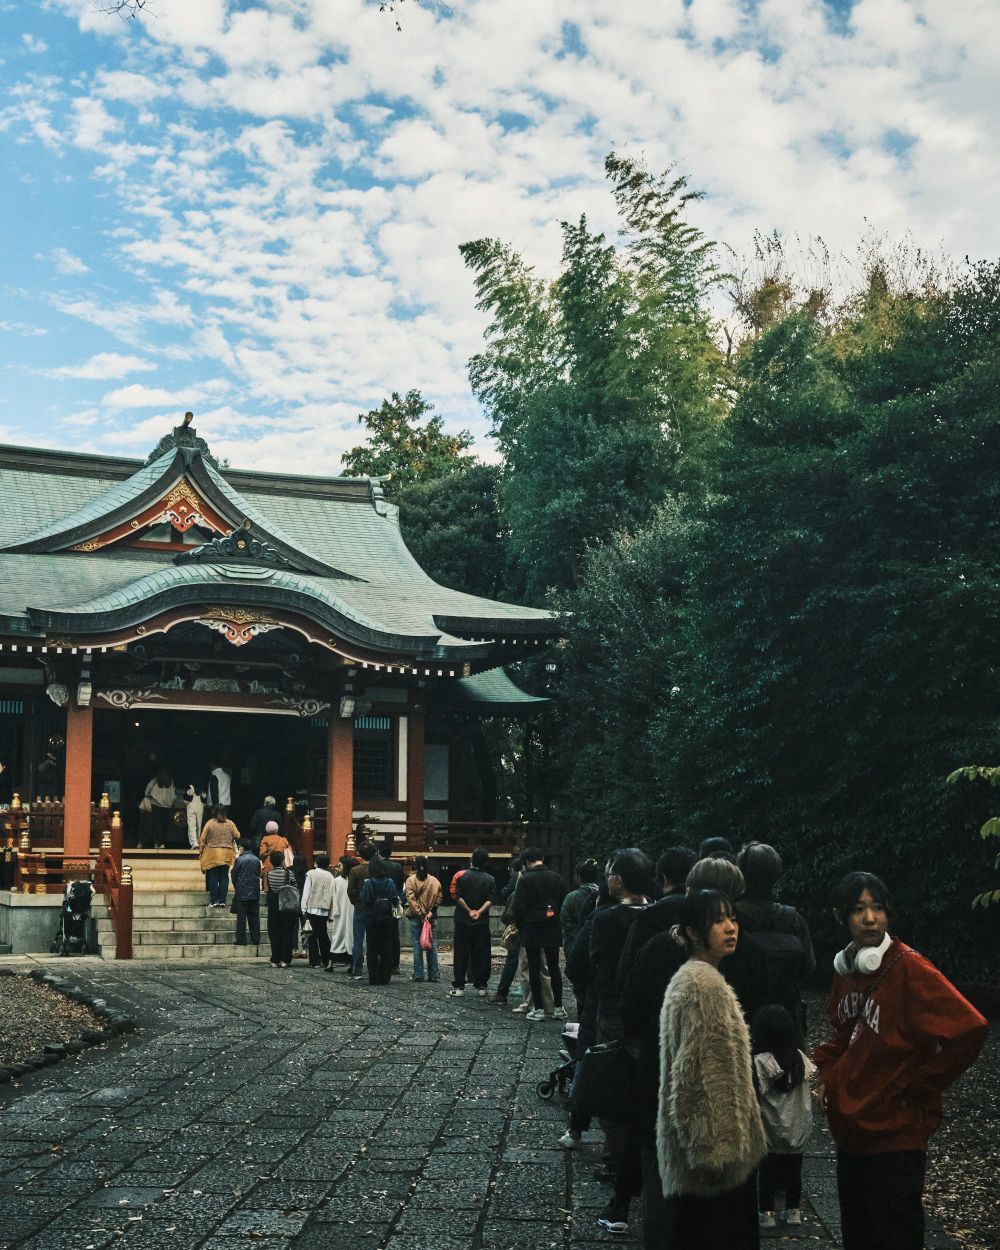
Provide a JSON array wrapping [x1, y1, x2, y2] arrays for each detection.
[[650, 253, 1000, 970]]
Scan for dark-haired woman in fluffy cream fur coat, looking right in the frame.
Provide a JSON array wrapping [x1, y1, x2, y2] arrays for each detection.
[[656, 890, 768, 1250]]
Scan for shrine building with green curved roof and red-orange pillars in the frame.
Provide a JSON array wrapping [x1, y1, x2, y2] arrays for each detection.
[[0, 414, 556, 875]]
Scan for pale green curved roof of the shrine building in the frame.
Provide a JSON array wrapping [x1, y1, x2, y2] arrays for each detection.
[[0, 435, 555, 660]]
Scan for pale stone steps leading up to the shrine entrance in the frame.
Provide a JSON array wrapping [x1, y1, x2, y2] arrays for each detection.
[[93, 850, 270, 960]]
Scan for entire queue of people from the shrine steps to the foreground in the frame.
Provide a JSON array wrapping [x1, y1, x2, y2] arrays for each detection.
[[191, 808, 986, 1250]]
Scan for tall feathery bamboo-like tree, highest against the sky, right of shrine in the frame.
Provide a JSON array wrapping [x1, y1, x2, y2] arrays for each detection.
[[460, 154, 725, 601]]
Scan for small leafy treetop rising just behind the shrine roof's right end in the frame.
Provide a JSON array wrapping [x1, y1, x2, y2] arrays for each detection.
[[341, 390, 475, 500]]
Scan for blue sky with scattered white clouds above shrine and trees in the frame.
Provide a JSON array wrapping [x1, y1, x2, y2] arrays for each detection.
[[0, 0, 1000, 473]]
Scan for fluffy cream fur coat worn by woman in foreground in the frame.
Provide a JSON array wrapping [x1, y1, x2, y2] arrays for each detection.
[[656, 959, 768, 1198]]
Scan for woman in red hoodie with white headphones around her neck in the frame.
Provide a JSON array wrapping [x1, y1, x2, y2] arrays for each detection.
[[813, 873, 988, 1250]]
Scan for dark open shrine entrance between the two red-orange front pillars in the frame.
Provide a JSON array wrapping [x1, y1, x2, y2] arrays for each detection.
[[93, 708, 329, 846]]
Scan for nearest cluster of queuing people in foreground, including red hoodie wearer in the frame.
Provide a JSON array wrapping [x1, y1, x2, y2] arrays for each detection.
[[550, 840, 986, 1250]]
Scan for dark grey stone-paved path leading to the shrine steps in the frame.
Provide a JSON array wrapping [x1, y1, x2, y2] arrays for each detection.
[[0, 959, 950, 1250]]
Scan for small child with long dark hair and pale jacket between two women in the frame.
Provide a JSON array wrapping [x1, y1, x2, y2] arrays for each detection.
[[751, 1004, 816, 1229]]
